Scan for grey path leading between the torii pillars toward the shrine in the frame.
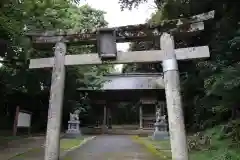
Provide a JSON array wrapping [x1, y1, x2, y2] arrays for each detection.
[[62, 135, 158, 160]]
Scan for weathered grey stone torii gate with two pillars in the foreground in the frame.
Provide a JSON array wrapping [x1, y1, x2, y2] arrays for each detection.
[[27, 11, 214, 160]]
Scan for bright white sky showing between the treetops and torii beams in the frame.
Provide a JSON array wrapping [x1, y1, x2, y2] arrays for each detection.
[[81, 0, 155, 71]]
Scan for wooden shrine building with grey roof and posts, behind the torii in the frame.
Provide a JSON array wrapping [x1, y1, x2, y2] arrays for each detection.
[[78, 73, 165, 129]]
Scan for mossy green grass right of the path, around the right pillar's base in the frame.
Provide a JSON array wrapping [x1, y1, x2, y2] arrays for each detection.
[[134, 126, 240, 160]]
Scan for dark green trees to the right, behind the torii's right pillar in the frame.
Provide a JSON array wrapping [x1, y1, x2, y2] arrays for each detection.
[[120, 0, 240, 130]]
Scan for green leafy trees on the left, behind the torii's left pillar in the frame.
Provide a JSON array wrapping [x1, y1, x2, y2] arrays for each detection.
[[0, 0, 112, 132]]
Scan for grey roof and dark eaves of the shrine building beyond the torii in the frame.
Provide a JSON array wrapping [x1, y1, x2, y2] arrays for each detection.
[[78, 73, 165, 101]]
